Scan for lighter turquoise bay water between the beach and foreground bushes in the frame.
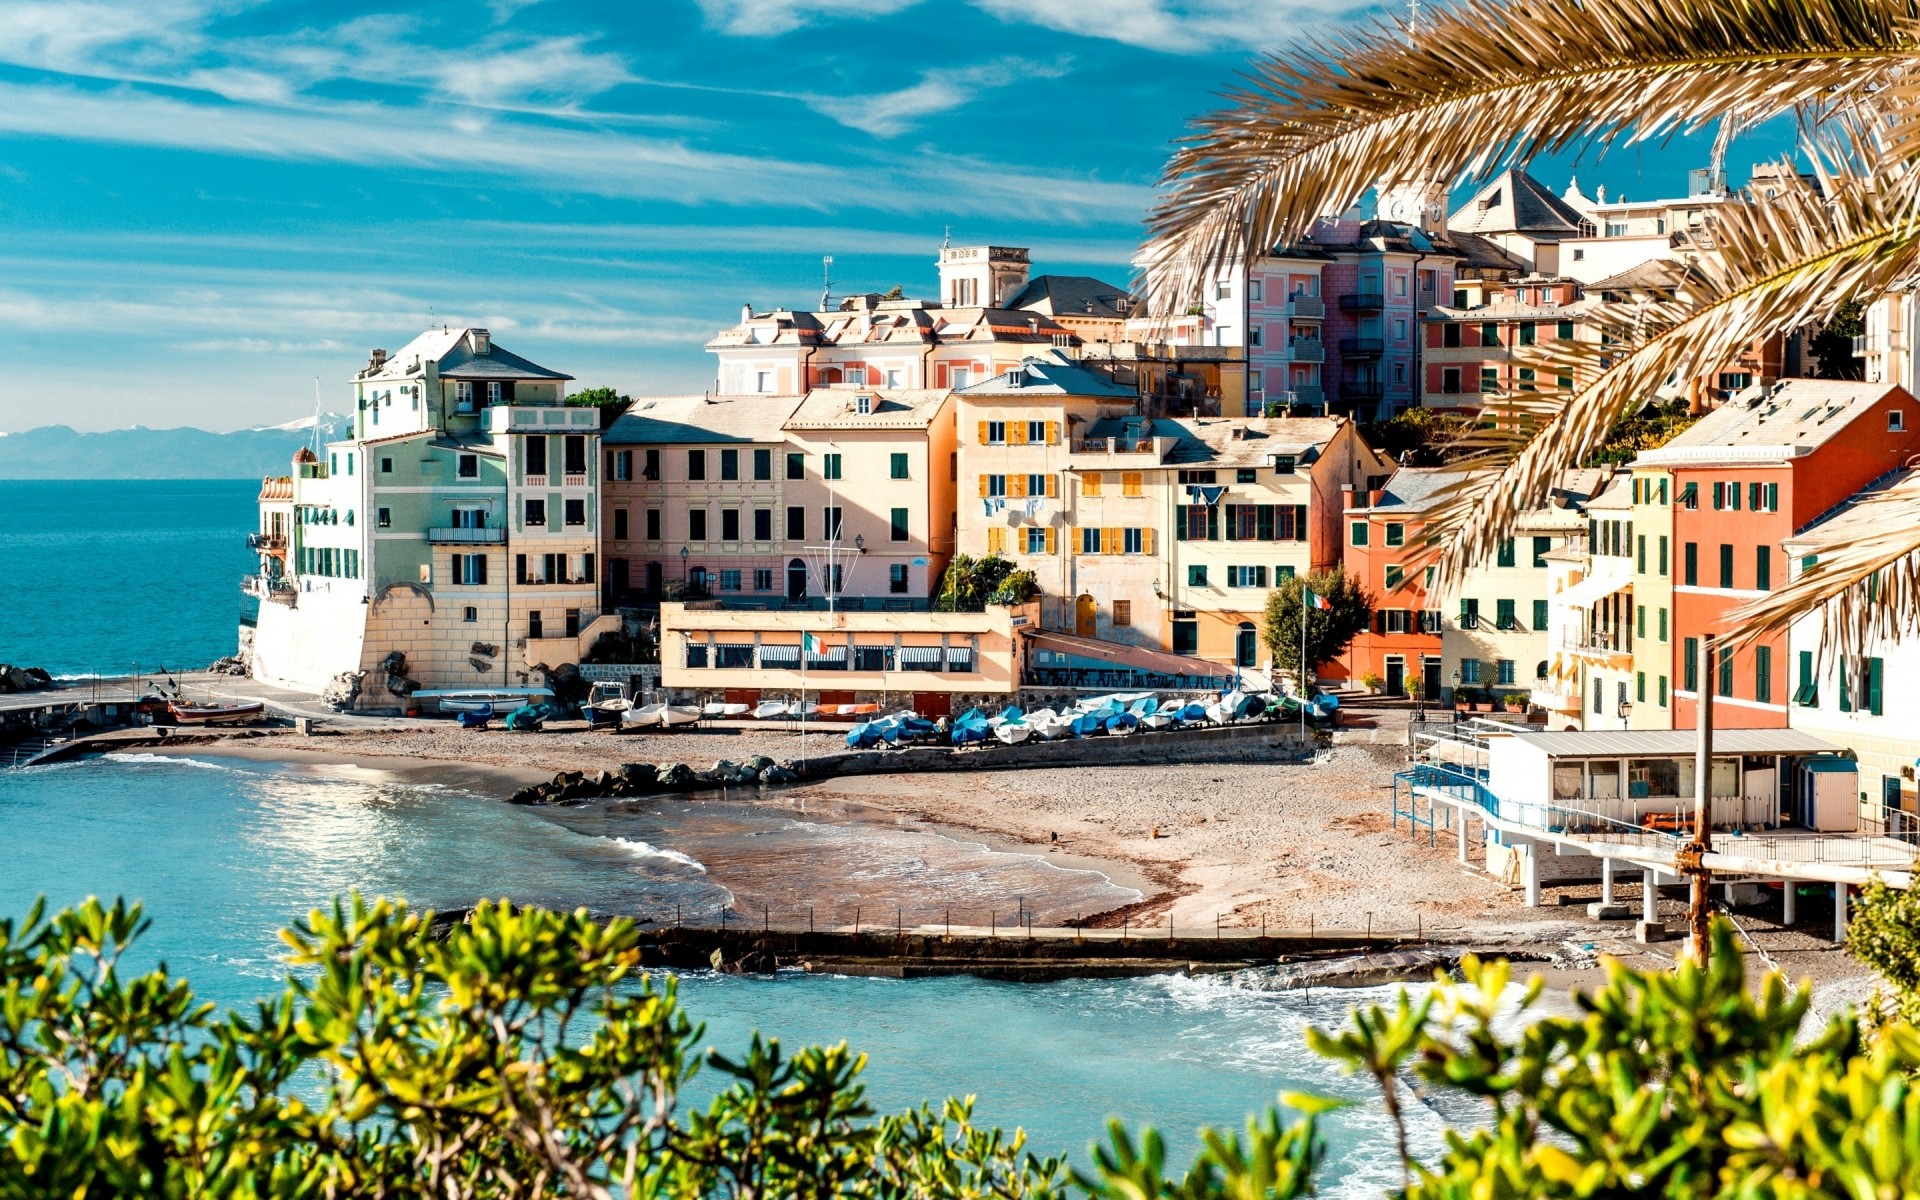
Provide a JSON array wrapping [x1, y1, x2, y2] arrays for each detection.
[[0, 755, 1438, 1194]]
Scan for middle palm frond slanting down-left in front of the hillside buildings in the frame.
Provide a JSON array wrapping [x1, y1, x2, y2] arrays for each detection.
[[1430, 167, 1920, 584]]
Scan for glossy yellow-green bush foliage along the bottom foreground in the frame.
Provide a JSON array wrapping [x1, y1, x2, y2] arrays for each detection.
[[0, 897, 1920, 1200]]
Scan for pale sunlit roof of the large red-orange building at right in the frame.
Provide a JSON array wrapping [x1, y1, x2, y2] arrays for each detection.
[[1634, 378, 1920, 465]]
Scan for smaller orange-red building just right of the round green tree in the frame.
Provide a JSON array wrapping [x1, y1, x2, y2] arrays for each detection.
[[1317, 468, 1459, 695]]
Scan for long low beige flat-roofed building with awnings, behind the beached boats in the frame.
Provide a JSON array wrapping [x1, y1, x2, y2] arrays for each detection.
[[660, 603, 1035, 716]]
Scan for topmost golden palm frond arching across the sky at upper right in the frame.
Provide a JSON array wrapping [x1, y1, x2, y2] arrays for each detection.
[[1142, 0, 1920, 311]]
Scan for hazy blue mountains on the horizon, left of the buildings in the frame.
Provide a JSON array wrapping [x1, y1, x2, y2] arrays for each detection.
[[0, 413, 351, 480]]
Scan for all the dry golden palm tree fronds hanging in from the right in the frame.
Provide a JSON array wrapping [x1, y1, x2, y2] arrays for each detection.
[[1142, 0, 1920, 657]]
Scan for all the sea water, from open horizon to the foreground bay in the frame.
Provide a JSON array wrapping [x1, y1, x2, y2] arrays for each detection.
[[0, 482, 1444, 1196]]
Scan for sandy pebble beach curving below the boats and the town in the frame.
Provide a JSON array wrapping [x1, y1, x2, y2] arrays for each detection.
[[116, 714, 1866, 996]]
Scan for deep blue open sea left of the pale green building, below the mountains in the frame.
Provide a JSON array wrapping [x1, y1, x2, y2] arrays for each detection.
[[0, 480, 259, 674]]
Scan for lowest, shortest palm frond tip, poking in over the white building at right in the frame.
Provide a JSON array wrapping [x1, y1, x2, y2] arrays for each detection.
[[1730, 474, 1920, 662]]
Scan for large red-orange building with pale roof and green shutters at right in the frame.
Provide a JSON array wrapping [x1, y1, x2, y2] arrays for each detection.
[[1634, 378, 1920, 730]]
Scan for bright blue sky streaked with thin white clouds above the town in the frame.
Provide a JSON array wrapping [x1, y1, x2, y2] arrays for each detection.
[[0, 0, 1784, 432]]
